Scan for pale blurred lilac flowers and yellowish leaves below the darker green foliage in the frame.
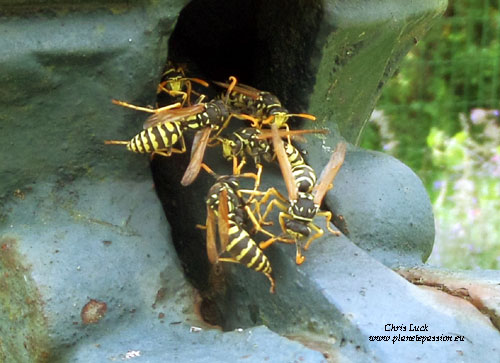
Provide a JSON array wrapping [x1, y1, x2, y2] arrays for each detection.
[[428, 126, 500, 269]]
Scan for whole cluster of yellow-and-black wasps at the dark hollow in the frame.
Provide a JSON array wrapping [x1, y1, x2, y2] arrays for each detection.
[[105, 63, 346, 293]]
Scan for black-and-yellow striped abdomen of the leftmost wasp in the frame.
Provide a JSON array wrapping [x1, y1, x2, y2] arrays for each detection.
[[127, 122, 183, 154]]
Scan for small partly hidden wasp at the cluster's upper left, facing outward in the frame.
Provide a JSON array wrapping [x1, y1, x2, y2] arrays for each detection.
[[156, 62, 209, 106]]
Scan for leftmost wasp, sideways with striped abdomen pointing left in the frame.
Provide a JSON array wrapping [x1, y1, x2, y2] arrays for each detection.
[[105, 100, 231, 160]]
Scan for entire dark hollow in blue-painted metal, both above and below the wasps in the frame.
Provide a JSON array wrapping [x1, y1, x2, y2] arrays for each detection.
[[151, 0, 323, 310]]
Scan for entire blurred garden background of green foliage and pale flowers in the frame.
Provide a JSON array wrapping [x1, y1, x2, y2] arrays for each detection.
[[361, 0, 500, 269]]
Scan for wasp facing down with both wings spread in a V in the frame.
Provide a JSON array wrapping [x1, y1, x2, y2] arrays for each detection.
[[258, 125, 346, 265]]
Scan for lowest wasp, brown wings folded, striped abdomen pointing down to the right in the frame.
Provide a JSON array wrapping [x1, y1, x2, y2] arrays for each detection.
[[203, 165, 282, 293]]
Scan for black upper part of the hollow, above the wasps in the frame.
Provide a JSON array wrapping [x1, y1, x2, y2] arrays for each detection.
[[169, 0, 323, 112]]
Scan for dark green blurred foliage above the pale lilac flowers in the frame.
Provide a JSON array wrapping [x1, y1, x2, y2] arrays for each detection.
[[362, 0, 500, 178]]
